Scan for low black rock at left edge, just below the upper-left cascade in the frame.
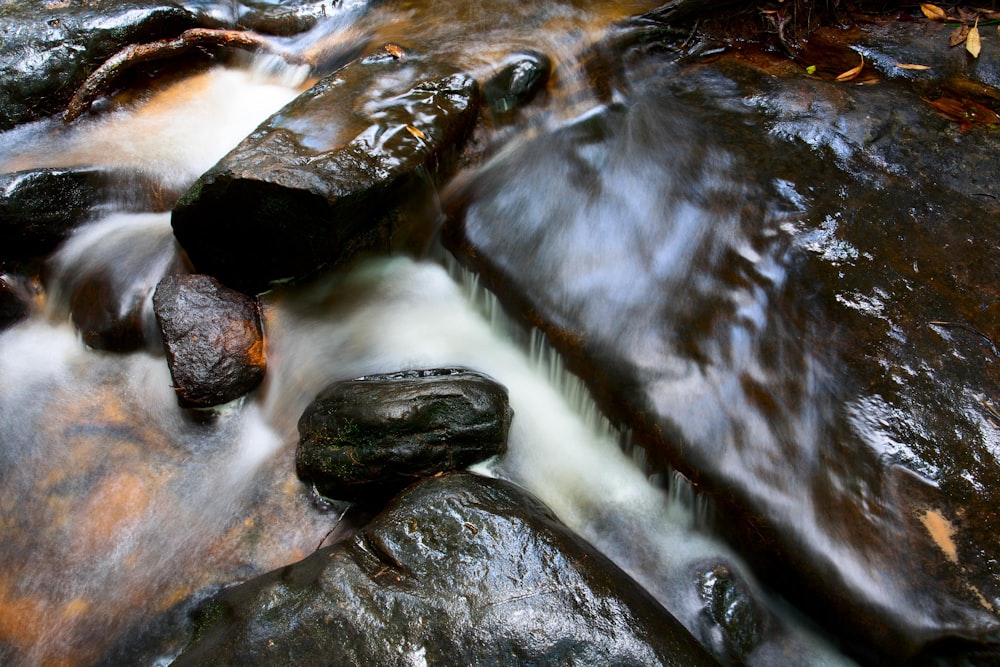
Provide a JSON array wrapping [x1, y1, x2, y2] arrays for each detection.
[[0, 167, 170, 260]]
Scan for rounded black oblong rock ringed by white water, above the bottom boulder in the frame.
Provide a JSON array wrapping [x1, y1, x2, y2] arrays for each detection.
[[296, 369, 512, 500]]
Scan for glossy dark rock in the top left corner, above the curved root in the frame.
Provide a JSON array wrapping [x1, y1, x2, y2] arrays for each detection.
[[0, 0, 196, 130]]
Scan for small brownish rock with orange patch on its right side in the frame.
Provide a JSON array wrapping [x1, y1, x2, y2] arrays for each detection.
[[153, 275, 266, 408]]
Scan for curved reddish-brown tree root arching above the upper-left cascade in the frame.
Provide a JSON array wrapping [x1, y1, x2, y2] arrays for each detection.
[[63, 28, 301, 123]]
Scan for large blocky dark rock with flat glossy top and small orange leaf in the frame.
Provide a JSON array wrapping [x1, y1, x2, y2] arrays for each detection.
[[173, 52, 478, 293]]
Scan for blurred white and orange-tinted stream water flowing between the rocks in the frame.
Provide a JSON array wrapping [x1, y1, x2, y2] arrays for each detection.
[[0, 0, 868, 664]]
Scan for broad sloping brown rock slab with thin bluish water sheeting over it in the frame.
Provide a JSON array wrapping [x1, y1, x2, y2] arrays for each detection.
[[445, 63, 1000, 662]]
